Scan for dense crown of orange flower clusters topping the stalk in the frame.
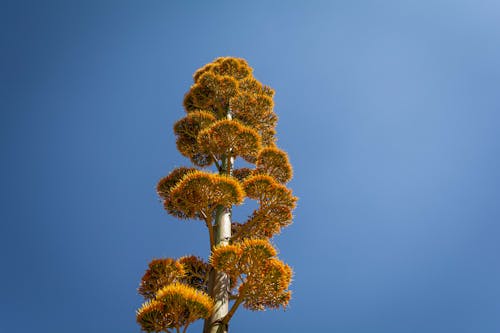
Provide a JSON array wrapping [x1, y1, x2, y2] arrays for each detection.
[[178, 58, 278, 167]]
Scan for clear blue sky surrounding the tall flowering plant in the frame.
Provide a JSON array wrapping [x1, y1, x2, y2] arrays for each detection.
[[0, 0, 500, 333]]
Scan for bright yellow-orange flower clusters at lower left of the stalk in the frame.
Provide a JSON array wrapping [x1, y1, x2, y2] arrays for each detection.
[[136, 256, 213, 332]]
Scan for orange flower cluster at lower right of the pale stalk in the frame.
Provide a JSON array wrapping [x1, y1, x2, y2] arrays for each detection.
[[210, 239, 292, 310]]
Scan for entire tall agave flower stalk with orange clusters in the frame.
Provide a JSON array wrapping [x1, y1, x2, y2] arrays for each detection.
[[137, 58, 296, 333]]
